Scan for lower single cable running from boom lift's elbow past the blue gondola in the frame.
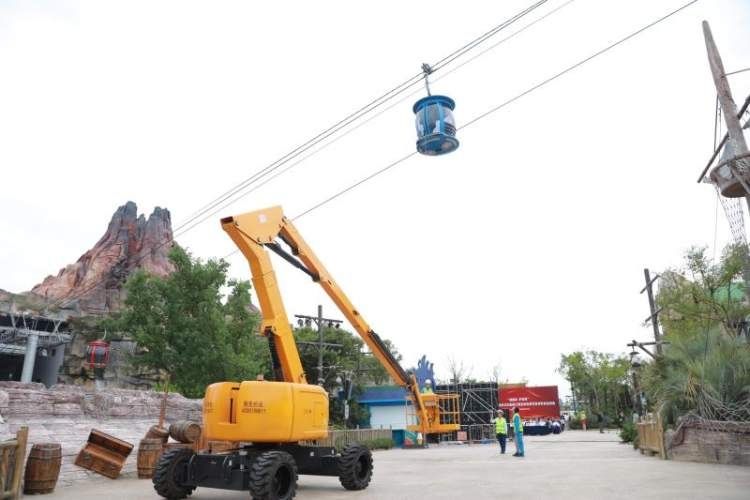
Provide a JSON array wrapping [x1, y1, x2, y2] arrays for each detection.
[[292, 0, 698, 221]]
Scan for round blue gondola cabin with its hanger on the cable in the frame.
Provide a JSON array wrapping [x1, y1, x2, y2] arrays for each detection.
[[413, 64, 458, 156]]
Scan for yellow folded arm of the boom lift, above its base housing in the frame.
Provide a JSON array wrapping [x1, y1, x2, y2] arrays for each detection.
[[221, 206, 452, 434]]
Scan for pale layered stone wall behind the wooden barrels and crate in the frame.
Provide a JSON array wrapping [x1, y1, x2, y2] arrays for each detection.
[[0, 382, 202, 486]]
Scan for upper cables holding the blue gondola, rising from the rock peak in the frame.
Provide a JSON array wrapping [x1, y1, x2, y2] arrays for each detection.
[[175, 0, 549, 231]]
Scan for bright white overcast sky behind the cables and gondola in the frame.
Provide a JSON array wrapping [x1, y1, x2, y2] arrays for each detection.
[[0, 0, 750, 392]]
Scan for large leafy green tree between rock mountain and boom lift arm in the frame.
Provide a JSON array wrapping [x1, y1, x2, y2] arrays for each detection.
[[108, 247, 269, 397]]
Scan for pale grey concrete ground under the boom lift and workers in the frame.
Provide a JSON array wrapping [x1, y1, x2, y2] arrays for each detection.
[[47, 431, 750, 500]]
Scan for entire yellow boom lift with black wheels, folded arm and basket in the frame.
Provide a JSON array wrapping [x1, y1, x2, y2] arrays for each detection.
[[153, 207, 459, 500]]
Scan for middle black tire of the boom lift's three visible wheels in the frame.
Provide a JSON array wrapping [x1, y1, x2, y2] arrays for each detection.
[[250, 451, 297, 500]]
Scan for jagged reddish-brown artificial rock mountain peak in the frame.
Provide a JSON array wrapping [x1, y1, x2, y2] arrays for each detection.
[[31, 201, 174, 312]]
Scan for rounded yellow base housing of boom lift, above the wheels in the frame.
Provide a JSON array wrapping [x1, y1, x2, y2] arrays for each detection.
[[203, 381, 328, 443]]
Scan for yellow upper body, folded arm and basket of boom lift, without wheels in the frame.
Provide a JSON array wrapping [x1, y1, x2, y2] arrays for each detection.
[[209, 203, 460, 443]]
